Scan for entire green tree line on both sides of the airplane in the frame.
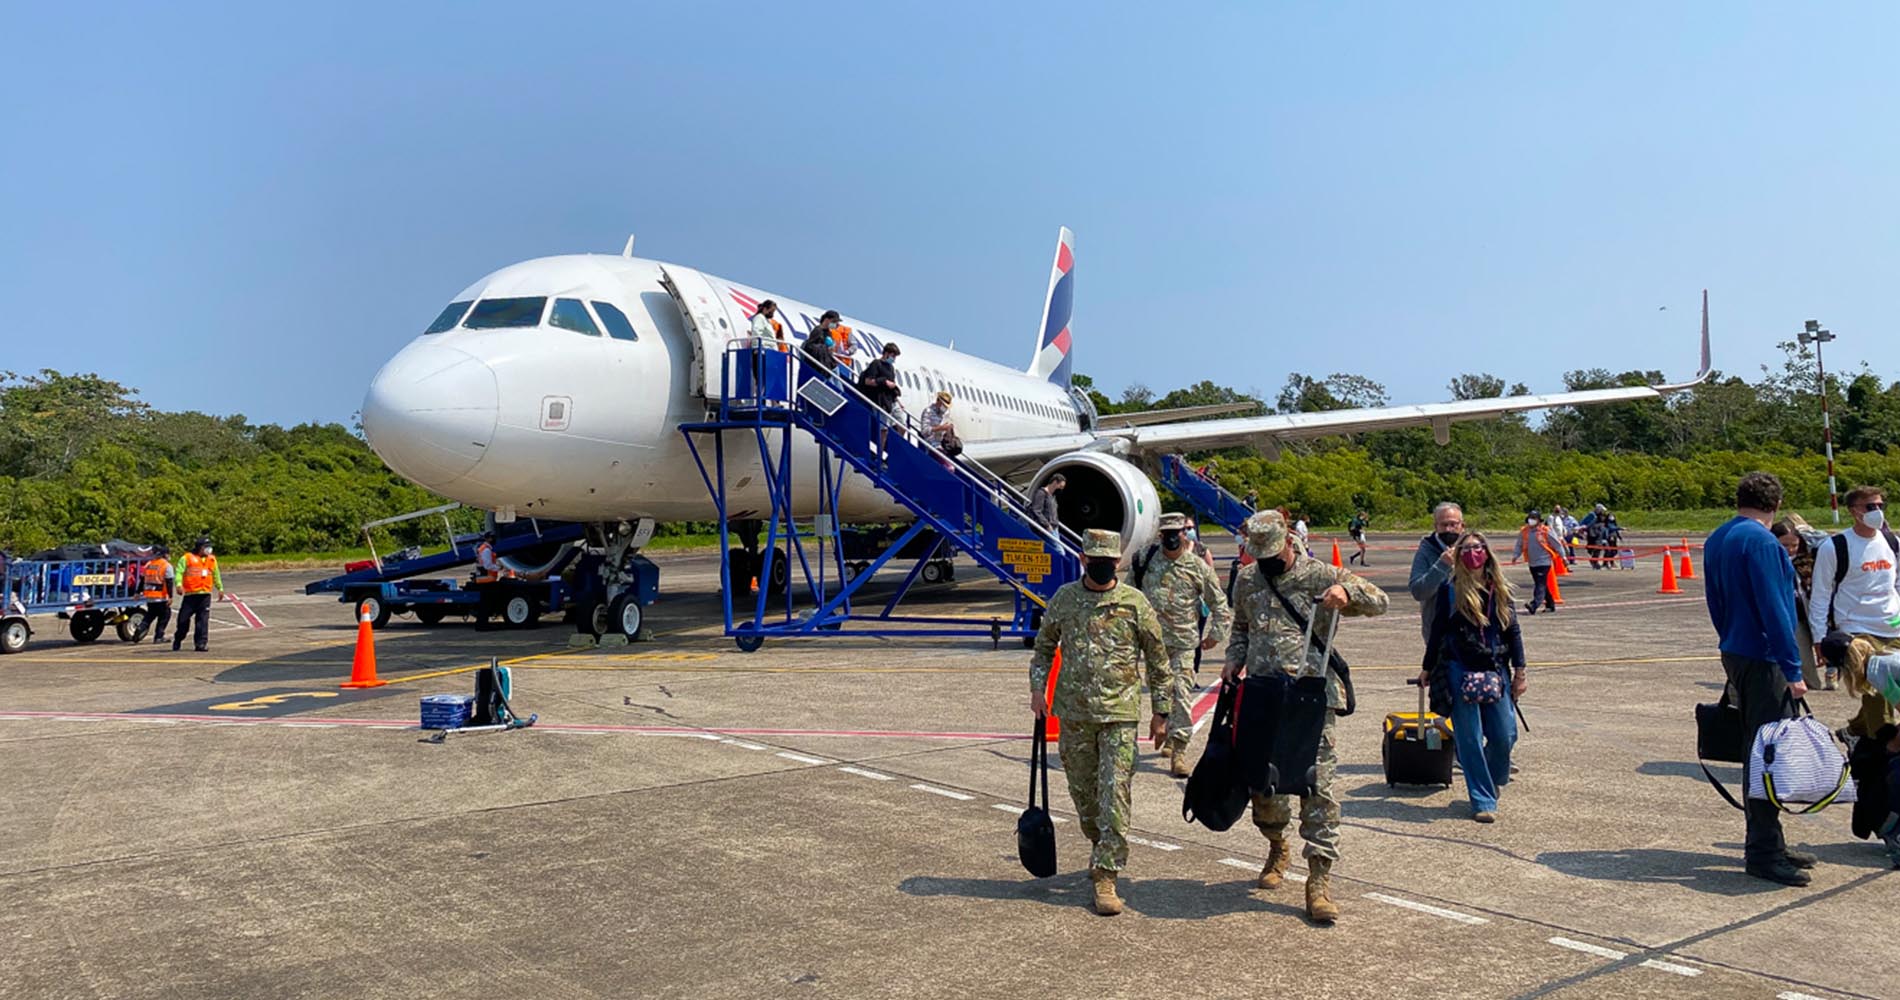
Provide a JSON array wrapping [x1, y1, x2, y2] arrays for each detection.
[[0, 342, 1877, 553]]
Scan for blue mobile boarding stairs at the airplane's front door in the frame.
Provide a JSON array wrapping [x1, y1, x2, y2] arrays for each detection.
[[680, 340, 1081, 652]]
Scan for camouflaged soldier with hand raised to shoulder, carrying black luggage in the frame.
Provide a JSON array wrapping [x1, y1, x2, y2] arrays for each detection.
[[1222, 510, 1385, 924]]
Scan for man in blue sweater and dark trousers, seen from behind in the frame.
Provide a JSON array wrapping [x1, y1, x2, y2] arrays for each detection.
[[1702, 471, 1815, 886]]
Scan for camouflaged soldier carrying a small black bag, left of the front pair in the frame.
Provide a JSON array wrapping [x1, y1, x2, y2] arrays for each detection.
[[1030, 529, 1172, 916]]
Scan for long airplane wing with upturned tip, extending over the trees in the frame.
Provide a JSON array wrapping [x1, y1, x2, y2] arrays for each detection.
[[963, 293, 1710, 475]]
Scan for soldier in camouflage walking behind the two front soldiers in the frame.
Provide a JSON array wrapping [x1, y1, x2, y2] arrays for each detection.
[[1134, 513, 1233, 778]]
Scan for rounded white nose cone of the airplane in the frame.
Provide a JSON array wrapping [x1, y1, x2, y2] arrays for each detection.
[[363, 342, 500, 489]]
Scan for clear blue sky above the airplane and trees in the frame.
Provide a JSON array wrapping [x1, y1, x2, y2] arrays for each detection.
[[0, 2, 1900, 422]]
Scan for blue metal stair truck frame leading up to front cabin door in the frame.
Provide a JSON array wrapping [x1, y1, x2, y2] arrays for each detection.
[[680, 346, 1081, 648]]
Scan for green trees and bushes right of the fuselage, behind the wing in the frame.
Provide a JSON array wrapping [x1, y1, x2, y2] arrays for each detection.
[[1075, 342, 1900, 525]]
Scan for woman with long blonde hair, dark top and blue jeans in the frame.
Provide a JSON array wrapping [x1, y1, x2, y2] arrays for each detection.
[[1419, 532, 1526, 823]]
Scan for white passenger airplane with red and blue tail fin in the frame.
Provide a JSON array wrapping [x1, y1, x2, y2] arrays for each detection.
[[363, 228, 1708, 631]]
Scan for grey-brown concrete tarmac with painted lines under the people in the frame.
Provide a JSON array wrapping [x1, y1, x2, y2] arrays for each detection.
[[0, 536, 1900, 1000]]
